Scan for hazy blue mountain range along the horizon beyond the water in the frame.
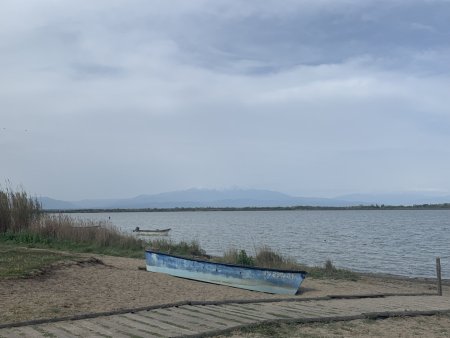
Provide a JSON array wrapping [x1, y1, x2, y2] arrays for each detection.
[[38, 189, 450, 210]]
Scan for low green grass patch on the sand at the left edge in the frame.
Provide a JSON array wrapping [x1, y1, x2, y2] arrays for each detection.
[[0, 245, 75, 278]]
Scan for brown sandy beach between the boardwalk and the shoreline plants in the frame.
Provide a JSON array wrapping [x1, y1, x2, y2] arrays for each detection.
[[0, 251, 442, 323]]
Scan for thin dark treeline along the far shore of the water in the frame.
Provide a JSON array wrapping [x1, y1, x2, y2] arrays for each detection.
[[44, 203, 450, 213]]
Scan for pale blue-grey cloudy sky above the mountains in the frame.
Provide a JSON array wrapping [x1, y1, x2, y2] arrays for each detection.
[[0, 0, 450, 200]]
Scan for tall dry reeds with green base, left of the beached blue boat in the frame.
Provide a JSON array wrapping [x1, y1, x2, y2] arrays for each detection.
[[0, 188, 145, 255]]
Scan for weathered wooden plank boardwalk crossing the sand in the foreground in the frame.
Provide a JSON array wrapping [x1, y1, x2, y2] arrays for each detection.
[[0, 295, 450, 338]]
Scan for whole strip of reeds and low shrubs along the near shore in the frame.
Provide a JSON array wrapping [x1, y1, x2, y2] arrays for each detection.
[[0, 189, 358, 280]]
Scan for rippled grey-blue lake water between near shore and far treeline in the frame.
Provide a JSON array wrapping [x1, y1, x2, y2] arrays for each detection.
[[66, 210, 450, 278]]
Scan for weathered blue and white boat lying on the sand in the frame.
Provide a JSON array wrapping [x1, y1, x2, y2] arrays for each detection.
[[145, 250, 306, 295]]
